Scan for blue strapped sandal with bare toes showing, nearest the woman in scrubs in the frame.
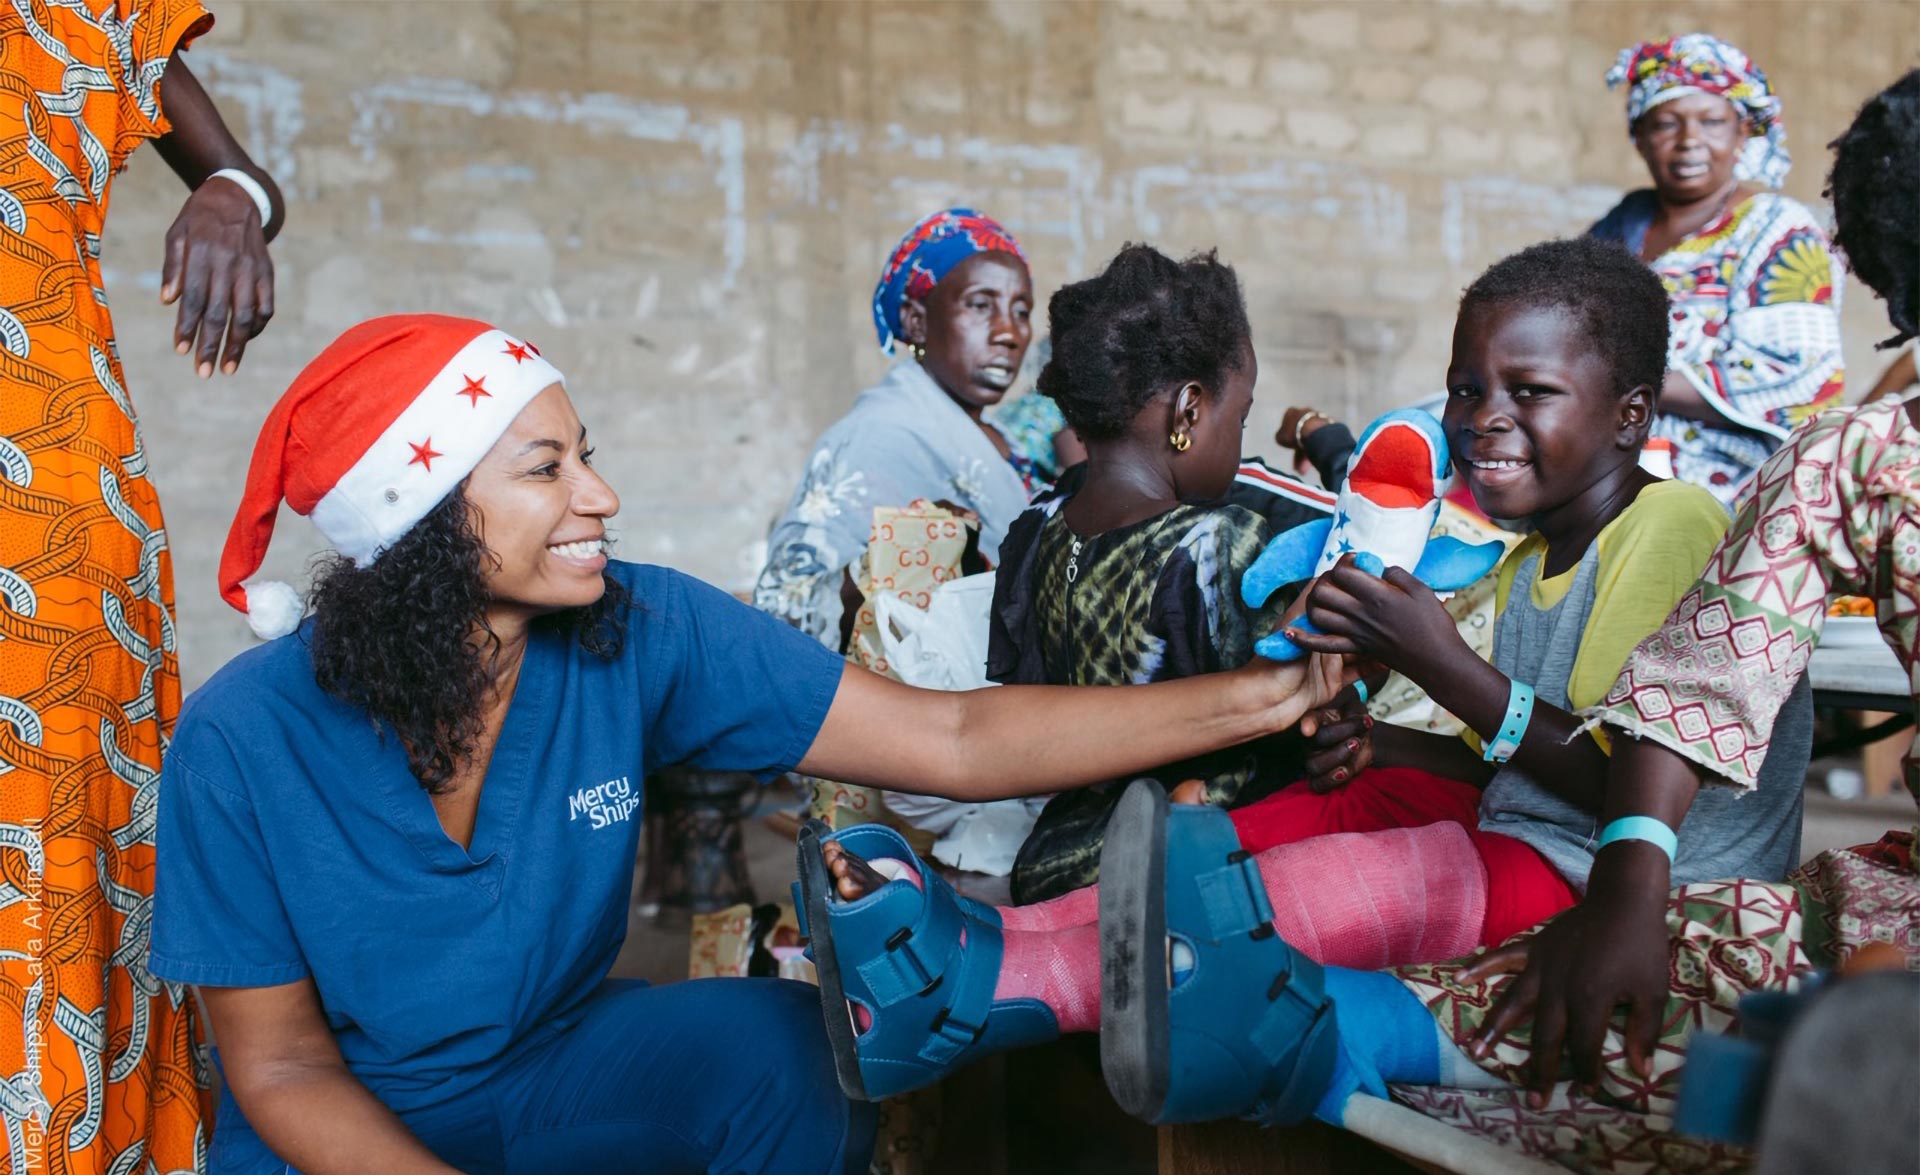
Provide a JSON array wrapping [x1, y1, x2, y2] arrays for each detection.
[[795, 820, 1060, 1102]]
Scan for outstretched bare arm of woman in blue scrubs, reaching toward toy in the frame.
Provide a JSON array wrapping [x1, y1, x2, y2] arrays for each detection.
[[799, 655, 1354, 801]]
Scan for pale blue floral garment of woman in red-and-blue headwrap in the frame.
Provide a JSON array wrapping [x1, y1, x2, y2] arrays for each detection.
[[753, 361, 1027, 647]]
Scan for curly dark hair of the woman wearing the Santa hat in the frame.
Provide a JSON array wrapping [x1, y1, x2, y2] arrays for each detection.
[[309, 482, 632, 795]]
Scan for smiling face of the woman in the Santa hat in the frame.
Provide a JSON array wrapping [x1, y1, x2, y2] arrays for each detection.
[[467, 384, 620, 618]]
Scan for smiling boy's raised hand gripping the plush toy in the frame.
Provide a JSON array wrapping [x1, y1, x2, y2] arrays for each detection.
[[1286, 555, 1475, 682]]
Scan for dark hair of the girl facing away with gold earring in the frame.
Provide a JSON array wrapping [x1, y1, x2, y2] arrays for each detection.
[[1035, 244, 1252, 440]]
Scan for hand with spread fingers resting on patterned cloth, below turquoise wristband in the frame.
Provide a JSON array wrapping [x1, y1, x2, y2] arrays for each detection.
[[1461, 845, 1668, 1108]]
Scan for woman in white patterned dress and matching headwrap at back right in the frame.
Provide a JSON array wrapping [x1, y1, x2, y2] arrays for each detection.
[[1590, 33, 1841, 507]]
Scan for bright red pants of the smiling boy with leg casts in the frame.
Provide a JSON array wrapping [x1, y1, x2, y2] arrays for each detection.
[[1229, 768, 1578, 947]]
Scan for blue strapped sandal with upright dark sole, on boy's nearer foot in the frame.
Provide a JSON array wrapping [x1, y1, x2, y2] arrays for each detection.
[[1100, 779, 1338, 1125]]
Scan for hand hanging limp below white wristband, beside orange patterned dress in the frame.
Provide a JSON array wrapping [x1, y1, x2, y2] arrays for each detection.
[[159, 179, 273, 378]]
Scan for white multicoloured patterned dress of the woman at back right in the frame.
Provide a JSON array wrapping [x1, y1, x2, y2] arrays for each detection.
[[1590, 190, 1843, 509]]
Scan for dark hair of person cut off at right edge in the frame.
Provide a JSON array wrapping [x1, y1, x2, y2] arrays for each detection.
[[1826, 69, 1920, 348]]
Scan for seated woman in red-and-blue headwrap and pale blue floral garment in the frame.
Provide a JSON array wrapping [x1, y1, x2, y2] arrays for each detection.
[[753, 207, 1033, 649]]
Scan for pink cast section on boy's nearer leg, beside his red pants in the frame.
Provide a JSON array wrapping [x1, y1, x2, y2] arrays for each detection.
[[1256, 824, 1486, 970]]
